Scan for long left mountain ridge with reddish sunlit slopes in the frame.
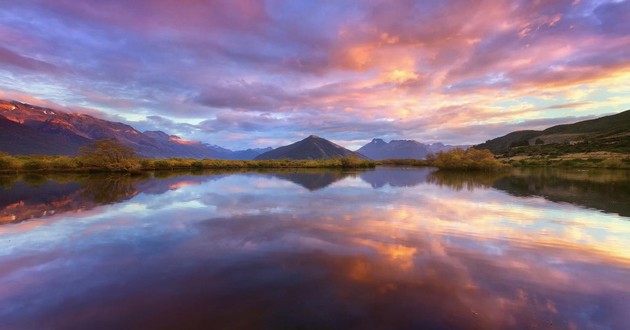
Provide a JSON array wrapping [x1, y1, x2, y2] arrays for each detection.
[[0, 101, 269, 159]]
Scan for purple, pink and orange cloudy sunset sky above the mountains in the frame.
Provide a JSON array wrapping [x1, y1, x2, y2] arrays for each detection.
[[0, 0, 630, 149]]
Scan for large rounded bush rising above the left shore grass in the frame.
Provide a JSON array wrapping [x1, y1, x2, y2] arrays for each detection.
[[79, 140, 140, 171]]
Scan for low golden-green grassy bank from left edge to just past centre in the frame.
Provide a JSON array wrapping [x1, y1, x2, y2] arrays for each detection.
[[0, 155, 377, 173]]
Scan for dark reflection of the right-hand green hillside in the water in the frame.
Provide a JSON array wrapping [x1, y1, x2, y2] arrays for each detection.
[[428, 168, 630, 217]]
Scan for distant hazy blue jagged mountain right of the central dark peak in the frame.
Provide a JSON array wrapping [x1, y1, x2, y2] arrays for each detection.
[[356, 139, 466, 160]]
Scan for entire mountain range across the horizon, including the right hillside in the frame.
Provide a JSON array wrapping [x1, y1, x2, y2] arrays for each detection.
[[11, 100, 630, 160]]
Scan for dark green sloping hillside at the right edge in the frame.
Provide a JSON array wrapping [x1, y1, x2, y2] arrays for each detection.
[[475, 110, 630, 153]]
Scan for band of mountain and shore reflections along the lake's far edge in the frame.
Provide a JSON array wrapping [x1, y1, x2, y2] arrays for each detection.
[[0, 167, 630, 224]]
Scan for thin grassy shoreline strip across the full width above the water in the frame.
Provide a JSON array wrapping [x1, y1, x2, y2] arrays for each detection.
[[0, 154, 630, 174]]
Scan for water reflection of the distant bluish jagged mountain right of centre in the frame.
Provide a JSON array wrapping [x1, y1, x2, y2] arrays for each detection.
[[361, 167, 435, 188]]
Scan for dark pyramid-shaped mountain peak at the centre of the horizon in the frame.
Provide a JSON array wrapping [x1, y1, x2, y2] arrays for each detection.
[[255, 135, 367, 160]]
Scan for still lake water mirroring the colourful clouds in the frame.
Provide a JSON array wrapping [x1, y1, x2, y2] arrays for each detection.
[[0, 168, 630, 329]]
